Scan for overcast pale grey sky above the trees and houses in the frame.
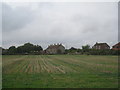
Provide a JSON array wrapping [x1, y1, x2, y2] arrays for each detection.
[[2, 2, 118, 49]]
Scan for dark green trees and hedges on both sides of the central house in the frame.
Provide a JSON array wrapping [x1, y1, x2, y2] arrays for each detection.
[[2, 43, 120, 55]]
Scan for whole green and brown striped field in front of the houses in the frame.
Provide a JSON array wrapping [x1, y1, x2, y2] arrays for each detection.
[[2, 55, 118, 88]]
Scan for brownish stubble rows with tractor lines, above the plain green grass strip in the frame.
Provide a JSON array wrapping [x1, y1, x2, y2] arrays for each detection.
[[3, 55, 117, 74]]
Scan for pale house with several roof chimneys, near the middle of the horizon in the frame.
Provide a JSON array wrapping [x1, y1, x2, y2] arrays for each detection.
[[45, 44, 65, 54]]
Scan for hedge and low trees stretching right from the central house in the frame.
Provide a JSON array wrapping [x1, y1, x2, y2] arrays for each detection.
[[65, 45, 120, 55]]
